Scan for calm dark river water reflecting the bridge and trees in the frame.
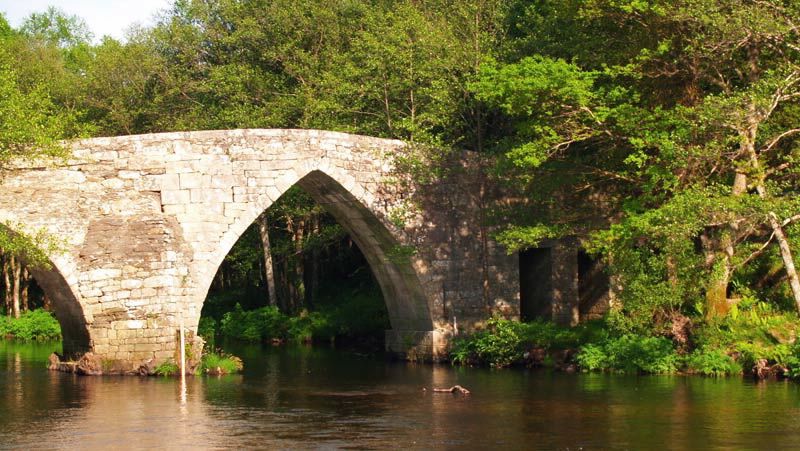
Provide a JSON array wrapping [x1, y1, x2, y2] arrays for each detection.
[[0, 341, 800, 449]]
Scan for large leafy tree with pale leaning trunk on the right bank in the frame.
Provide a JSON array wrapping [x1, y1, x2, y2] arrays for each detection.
[[473, 0, 800, 324]]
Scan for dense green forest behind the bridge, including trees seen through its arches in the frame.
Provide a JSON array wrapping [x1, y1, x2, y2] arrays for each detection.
[[0, 0, 800, 364]]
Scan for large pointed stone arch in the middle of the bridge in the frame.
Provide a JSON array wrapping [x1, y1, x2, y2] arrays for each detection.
[[195, 168, 433, 331]]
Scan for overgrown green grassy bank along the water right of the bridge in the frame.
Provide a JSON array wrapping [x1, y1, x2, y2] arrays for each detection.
[[451, 302, 800, 378]]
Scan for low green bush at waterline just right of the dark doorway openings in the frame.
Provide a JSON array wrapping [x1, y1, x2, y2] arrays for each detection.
[[576, 335, 681, 374]]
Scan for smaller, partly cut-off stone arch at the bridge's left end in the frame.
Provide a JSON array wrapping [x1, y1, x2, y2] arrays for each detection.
[[0, 225, 92, 356]]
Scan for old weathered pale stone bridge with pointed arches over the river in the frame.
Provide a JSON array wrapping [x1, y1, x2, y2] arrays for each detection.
[[0, 130, 600, 371]]
